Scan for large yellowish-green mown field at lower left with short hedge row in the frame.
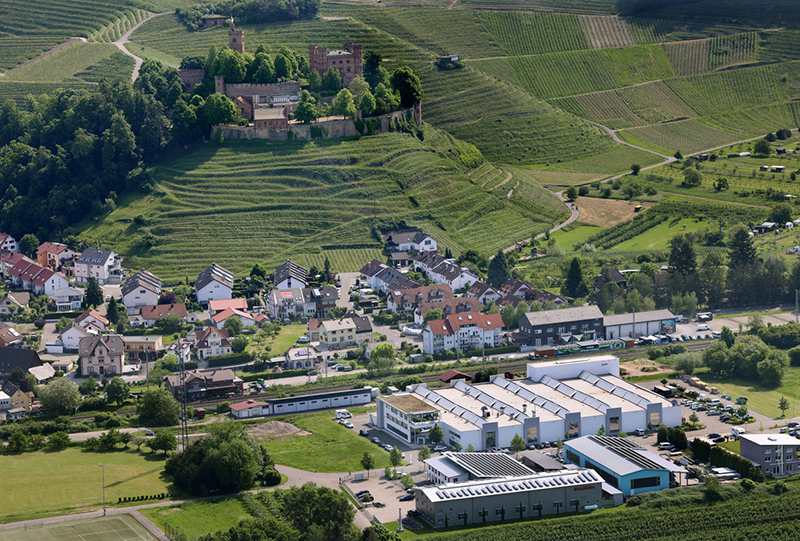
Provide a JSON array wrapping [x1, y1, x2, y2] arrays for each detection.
[[0, 447, 179, 522]]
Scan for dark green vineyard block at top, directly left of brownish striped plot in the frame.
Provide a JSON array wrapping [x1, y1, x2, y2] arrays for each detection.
[[479, 11, 589, 56]]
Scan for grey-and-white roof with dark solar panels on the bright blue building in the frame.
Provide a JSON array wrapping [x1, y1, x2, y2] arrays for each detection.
[[564, 436, 686, 476]]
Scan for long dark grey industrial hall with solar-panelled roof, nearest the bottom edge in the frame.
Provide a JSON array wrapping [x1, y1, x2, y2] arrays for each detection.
[[415, 470, 603, 528]]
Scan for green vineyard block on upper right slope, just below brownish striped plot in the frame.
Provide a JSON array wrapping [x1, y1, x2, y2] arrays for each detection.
[[509, 45, 672, 98]]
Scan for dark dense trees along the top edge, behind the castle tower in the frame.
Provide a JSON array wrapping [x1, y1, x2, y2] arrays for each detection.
[[175, 0, 322, 30]]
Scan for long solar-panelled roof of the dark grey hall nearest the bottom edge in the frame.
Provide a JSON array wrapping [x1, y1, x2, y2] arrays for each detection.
[[417, 469, 603, 502]]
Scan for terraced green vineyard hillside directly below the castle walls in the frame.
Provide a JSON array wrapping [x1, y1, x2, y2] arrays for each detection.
[[81, 132, 562, 283]]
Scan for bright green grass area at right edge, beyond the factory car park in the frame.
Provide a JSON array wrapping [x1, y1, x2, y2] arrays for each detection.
[[709, 366, 800, 418]]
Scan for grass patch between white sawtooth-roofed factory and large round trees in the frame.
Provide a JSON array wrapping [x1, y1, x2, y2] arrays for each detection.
[[262, 408, 390, 472]]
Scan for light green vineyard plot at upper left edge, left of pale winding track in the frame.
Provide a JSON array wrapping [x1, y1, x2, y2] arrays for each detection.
[[4, 42, 119, 82]]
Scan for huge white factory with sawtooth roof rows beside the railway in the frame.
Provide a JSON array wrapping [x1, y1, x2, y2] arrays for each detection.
[[376, 355, 681, 451]]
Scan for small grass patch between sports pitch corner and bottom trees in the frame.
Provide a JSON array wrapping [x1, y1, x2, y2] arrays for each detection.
[[142, 498, 250, 539]]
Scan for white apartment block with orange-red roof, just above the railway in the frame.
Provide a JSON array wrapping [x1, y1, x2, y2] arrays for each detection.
[[422, 312, 503, 355]]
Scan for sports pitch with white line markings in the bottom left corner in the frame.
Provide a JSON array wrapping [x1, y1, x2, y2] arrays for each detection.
[[0, 515, 154, 541]]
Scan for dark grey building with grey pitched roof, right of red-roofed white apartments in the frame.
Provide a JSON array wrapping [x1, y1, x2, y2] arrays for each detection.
[[519, 305, 603, 346]]
